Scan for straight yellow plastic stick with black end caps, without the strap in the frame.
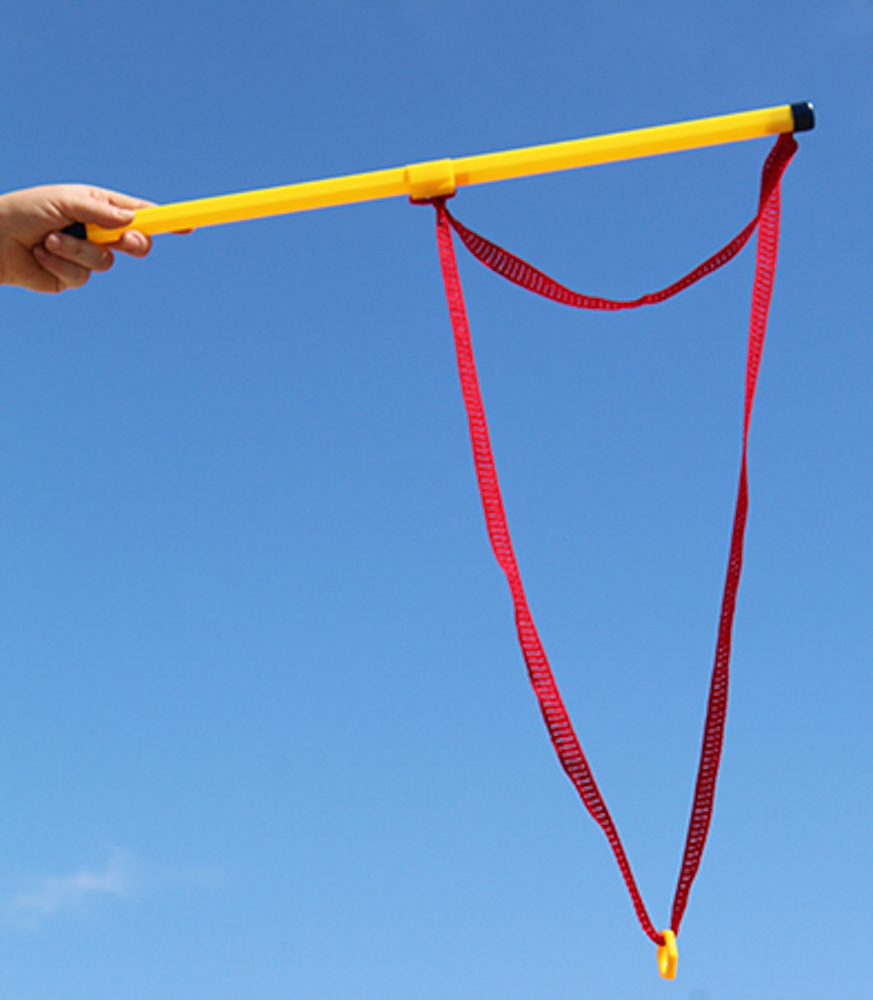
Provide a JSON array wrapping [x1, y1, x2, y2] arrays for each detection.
[[87, 103, 815, 243]]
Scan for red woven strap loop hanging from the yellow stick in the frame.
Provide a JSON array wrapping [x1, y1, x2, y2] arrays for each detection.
[[435, 136, 797, 945]]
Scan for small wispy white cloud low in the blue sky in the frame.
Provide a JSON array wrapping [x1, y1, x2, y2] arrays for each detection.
[[2, 850, 137, 928]]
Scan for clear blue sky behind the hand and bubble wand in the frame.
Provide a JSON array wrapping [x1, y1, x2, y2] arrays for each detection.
[[0, 0, 873, 1000]]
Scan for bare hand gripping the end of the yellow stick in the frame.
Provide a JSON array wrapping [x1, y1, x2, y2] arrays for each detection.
[[0, 184, 152, 292]]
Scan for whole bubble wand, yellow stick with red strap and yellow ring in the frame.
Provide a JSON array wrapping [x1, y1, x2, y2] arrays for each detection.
[[66, 103, 815, 979]]
